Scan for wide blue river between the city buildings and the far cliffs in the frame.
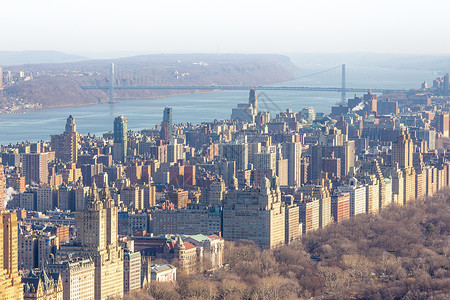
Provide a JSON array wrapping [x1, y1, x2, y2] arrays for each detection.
[[0, 65, 436, 145]]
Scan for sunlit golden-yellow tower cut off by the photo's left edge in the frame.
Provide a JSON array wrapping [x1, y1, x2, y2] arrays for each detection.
[[0, 211, 23, 299]]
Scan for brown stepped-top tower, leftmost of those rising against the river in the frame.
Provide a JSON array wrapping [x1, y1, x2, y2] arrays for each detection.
[[51, 115, 78, 163]]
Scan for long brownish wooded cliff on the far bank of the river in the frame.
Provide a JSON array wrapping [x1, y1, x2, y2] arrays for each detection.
[[4, 54, 296, 107]]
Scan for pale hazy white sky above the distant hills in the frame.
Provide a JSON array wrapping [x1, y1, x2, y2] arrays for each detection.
[[0, 0, 450, 54]]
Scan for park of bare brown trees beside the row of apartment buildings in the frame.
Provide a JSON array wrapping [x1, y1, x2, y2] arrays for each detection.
[[124, 190, 450, 300]]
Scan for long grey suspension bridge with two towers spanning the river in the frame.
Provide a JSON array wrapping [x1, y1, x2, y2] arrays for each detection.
[[81, 63, 407, 103]]
